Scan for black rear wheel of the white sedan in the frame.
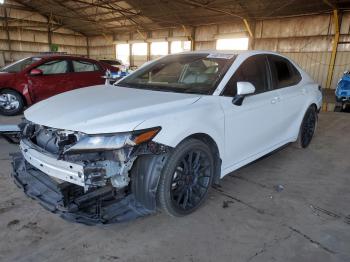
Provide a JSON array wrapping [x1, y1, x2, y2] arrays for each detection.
[[295, 106, 317, 148]]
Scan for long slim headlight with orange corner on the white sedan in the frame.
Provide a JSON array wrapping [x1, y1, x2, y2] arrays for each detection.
[[64, 127, 161, 154]]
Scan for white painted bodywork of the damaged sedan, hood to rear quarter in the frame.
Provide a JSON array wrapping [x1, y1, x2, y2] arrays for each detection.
[[25, 51, 322, 177]]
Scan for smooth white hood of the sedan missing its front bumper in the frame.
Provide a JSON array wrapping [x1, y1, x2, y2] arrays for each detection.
[[24, 85, 200, 134]]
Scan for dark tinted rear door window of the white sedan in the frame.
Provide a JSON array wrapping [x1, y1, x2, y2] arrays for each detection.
[[268, 55, 301, 89]]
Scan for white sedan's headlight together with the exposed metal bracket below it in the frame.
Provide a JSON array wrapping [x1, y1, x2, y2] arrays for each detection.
[[59, 127, 161, 188]]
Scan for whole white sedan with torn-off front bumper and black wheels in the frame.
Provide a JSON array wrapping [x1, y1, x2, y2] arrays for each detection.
[[1, 51, 322, 224]]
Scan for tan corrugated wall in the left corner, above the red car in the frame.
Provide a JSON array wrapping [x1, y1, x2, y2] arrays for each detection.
[[0, 1, 88, 66]]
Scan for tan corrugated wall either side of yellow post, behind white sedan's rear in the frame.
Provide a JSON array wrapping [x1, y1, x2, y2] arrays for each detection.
[[255, 12, 350, 89]]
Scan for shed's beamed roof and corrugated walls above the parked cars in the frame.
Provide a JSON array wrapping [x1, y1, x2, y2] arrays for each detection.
[[0, 0, 350, 89]]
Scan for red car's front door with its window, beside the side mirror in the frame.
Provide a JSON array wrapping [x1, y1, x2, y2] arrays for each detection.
[[27, 59, 70, 102]]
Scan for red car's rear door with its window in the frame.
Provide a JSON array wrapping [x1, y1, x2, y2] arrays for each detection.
[[71, 59, 105, 89]]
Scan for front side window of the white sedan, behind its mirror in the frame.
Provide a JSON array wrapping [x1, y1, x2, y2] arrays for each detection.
[[222, 55, 269, 97]]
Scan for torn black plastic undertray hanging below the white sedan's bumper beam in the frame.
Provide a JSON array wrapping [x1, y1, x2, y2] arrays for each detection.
[[12, 153, 154, 225]]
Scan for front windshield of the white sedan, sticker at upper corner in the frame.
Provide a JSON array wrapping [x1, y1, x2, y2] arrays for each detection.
[[116, 53, 235, 95]]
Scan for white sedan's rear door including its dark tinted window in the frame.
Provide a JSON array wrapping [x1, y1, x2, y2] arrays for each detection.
[[267, 55, 307, 139]]
